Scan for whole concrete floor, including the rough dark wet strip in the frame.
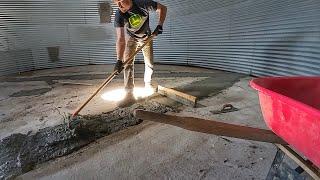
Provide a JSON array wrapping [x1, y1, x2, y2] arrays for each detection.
[[0, 64, 312, 180]]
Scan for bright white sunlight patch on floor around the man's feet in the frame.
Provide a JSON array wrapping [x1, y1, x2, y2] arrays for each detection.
[[101, 87, 154, 101]]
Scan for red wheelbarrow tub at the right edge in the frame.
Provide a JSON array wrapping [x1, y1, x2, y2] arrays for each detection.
[[250, 76, 320, 167]]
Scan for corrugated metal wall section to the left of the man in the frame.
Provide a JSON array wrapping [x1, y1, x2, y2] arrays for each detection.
[[0, 0, 115, 75]]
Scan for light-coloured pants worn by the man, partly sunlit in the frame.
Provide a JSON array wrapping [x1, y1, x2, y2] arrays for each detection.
[[124, 37, 153, 91]]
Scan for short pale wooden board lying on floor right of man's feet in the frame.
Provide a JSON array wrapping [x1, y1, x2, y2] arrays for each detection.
[[158, 85, 197, 107]]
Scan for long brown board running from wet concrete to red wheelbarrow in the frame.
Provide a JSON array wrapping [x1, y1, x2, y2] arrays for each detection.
[[134, 110, 288, 145]]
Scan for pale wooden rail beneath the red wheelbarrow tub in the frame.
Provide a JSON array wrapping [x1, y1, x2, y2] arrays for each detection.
[[276, 144, 320, 179]]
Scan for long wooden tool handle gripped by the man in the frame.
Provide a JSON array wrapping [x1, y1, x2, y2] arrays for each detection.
[[71, 34, 154, 119]]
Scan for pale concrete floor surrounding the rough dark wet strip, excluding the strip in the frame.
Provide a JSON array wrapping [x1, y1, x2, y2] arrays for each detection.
[[0, 64, 310, 179]]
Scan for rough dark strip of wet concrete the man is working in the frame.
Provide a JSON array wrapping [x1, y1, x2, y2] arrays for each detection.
[[0, 101, 176, 179]]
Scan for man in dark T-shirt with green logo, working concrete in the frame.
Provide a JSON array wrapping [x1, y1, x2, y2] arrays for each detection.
[[113, 0, 167, 106]]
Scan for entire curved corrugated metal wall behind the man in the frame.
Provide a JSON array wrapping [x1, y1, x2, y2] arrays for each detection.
[[0, 0, 320, 76]]
